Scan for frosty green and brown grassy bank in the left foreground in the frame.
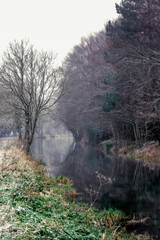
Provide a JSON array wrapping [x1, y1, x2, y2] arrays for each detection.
[[0, 144, 151, 240]]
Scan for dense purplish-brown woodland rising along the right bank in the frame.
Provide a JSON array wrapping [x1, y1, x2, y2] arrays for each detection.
[[58, 0, 160, 147]]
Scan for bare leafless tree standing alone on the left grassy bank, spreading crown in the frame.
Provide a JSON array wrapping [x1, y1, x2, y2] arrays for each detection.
[[0, 40, 66, 152]]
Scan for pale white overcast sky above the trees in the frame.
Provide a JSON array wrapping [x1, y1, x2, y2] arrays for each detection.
[[0, 0, 120, 62]]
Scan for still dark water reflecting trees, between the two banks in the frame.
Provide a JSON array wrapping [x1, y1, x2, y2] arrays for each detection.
[[32, 124, 160, 239]]
